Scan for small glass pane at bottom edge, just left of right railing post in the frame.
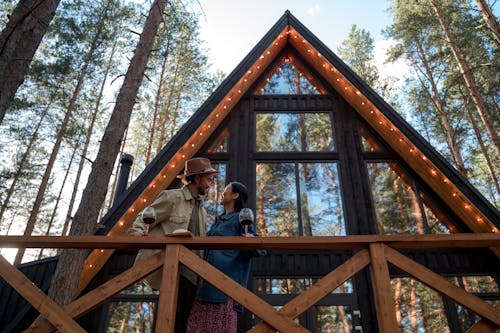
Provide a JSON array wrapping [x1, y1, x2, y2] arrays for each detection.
[[313, 305, 352, 333]]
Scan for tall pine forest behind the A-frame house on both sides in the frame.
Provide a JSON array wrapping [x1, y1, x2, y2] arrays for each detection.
[[0, 0, 500, 268]]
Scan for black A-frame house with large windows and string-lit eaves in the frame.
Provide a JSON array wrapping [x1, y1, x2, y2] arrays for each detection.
[[0, 11, 500, 333]]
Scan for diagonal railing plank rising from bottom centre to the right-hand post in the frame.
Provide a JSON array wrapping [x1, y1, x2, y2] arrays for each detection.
[[247, 250, 370, 333]]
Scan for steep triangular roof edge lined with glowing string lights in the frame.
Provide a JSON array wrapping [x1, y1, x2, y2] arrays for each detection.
[[80, 11, 500, 290]]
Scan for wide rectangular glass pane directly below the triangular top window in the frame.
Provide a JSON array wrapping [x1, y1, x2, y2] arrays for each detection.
[[256, 113, 335, 152]]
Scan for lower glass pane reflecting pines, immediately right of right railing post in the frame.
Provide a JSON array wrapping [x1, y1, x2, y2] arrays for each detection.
[[391, 278, 450, 333]]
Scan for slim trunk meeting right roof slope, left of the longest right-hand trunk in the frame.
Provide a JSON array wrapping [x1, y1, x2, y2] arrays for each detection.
[[417, 42, 467, 177]]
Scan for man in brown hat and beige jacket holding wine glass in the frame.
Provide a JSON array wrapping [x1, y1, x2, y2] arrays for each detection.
[[127, 157, 217, 332]]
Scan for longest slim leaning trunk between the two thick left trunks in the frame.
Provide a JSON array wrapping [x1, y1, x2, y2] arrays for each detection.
[[14, 1, 110, 264]]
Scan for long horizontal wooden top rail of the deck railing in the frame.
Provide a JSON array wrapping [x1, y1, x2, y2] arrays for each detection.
[[0, 233, 500, 250]]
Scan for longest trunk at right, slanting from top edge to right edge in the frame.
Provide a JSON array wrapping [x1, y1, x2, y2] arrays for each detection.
[[429, 0, 500, 155]]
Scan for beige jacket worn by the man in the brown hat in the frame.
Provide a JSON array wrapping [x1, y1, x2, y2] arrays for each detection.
[[127, 186, 207, 289]]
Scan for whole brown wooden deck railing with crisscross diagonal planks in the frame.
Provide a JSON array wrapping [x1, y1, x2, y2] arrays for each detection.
[[0, 234, 500, 333]]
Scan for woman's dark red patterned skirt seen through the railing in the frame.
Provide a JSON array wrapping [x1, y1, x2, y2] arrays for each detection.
[[186, 298, 238, 333]]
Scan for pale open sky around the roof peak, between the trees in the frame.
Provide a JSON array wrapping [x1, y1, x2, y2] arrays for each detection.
[[193, 0, 398, 74]]
